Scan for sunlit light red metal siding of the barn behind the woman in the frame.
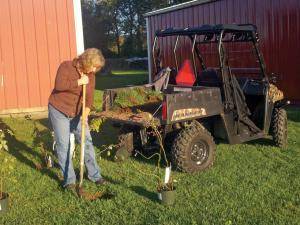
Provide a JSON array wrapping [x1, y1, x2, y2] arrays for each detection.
[[0, 0, 76, 110]]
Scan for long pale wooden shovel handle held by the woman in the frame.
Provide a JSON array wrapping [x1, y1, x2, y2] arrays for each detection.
[[79, 84, 86, 187]]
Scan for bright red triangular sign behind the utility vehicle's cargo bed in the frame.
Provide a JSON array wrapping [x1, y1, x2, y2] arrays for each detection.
[[175, 59, 196, 86]]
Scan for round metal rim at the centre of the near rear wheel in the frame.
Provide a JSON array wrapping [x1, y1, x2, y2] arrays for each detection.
[[191, 140, 209, 166]]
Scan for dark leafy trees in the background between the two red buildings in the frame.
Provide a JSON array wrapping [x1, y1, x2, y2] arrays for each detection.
[[82, 0, 190, 57]]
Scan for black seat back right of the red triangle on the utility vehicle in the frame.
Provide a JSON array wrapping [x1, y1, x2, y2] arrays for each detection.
[[196, 68, 222, 87]]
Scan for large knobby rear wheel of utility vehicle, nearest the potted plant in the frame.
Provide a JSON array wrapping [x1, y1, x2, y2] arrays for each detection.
[[172, 121, 216, 173]]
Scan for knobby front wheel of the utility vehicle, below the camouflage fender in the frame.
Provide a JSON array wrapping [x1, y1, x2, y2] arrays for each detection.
[[270, 108, 287, 148]]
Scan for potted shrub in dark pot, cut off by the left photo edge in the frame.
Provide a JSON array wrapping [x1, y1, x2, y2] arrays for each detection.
[[0, 124, 13, 215]]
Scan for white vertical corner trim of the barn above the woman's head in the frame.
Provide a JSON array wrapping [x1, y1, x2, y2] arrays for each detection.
[[73, 0, 84, 55]]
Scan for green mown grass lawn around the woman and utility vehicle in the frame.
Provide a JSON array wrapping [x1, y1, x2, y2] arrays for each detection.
[[0, 71, 300, 225]]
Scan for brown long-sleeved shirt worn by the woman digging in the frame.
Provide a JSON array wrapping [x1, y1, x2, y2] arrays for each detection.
[[49, 61, 95, 117]]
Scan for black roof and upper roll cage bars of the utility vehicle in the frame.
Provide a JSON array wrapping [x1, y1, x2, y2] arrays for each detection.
[[152, 24, 268, 79]]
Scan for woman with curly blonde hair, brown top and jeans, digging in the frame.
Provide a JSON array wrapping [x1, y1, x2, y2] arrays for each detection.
[[48, 48, 105, 189]]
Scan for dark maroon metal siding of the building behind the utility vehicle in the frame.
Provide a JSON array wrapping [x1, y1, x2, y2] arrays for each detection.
[[149, 0, 300, 100]]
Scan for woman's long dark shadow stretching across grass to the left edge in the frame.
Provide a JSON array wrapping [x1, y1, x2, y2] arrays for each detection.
[[0, 120, 59, 183]]
